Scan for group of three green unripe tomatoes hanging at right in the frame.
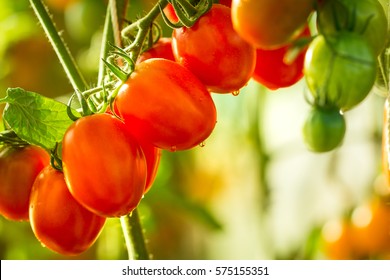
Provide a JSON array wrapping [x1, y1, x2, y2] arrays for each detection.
[[303, 0, 387, 152]]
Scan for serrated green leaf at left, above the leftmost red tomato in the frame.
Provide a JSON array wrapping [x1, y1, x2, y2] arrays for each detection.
[[0, 88, 72, 150]]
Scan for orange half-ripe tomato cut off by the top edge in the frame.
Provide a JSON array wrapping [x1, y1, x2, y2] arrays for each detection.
[[232, 0, 314, 49]]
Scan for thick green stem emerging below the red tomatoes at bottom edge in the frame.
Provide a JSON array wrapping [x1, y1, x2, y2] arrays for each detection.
[[120, 209, 150, 260]]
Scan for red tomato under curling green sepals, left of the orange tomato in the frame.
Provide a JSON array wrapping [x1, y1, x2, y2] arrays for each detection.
[[172, 4, 256, 93]]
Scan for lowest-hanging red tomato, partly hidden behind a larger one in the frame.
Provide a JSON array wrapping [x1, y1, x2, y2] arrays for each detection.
[[30, 165, 106, 255]]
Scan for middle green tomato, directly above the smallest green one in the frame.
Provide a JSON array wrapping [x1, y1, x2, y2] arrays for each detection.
[[304, 32, 377, 111]]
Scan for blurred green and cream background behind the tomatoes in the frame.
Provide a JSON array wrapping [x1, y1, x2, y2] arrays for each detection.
[[0, 0, 390, 259]]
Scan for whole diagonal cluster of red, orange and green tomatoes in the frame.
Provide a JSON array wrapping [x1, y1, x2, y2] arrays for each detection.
[[0, 0, 387, 255]]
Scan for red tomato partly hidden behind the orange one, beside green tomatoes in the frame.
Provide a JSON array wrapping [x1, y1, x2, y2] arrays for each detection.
[[252, 26, 310, 90]]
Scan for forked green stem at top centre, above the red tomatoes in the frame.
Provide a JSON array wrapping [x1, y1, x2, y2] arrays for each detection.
[[122, 0, 168, 61]]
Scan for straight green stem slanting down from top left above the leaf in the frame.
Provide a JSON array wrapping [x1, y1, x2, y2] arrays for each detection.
[[30, 0, 88, 92]]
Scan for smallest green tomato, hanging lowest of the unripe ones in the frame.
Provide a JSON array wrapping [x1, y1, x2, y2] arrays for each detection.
[[302, 106, 346, 153]]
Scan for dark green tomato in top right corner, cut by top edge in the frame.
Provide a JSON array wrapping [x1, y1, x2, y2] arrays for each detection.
[[317, 0, 387, 55]]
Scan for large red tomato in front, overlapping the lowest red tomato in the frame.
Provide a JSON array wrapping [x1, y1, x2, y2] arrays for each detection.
[[62, 114, 147, 217]]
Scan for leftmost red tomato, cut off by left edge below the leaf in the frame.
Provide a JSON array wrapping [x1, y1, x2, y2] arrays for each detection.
[[0, 146, 50, 221]]
